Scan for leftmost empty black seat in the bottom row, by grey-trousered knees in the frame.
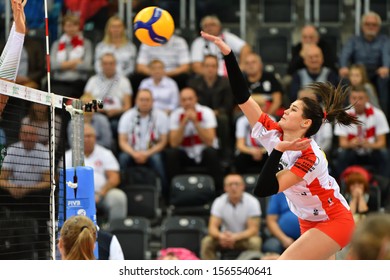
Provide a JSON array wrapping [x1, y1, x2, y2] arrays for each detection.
[[104, 217, 151, 260]]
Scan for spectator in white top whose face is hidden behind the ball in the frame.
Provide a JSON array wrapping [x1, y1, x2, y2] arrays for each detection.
[[136, 34, 190, 89]]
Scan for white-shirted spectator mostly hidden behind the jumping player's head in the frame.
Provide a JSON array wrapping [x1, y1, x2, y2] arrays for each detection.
[[298, 88, 333, 155]]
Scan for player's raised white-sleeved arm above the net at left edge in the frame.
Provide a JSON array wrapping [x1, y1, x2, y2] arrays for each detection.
[[0, 0, 27, 116]]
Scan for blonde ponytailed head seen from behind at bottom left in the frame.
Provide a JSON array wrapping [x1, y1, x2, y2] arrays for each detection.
[[60, 216, 96, 260]]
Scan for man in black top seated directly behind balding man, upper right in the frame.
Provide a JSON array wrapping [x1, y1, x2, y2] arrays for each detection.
[[287, 24, 337, 75]]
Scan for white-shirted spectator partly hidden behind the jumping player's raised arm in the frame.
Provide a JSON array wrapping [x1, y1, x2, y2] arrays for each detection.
[[234, 97, 268, 174]]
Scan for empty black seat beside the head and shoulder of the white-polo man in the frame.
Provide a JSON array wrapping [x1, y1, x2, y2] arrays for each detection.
[[167, 174, 216, 219]]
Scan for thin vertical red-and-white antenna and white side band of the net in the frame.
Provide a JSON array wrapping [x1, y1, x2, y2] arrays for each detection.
[[44, 0, 56, 260]]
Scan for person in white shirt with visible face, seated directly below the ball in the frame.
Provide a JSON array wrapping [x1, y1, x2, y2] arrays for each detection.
[[139, 59, 179, 115]]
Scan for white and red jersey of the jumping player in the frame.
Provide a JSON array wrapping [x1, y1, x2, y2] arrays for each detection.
[[252, 114, 349, 222]]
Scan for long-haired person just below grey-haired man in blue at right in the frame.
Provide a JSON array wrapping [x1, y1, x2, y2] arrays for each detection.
[[348, 64, 381, 109]]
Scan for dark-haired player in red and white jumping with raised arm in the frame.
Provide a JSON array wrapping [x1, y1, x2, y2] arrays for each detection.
[[201, 32, 359, 260]]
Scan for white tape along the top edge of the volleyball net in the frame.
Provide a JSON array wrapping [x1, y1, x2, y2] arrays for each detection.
[[0, 79, 68, 108]]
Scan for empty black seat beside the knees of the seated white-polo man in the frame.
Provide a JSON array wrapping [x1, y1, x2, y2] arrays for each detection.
[[161, 216, 207, 257]]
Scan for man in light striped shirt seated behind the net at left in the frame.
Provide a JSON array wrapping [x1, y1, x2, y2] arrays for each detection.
[[0, 124, 51, 259]]
